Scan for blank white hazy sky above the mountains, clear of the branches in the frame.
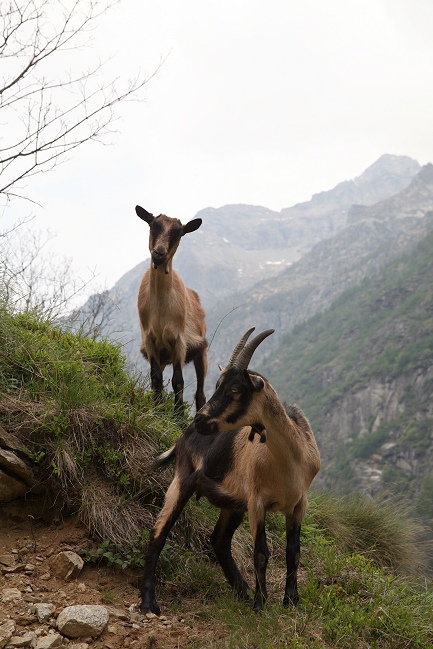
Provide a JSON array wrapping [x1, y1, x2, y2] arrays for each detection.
[[3, 0, 433, 287]]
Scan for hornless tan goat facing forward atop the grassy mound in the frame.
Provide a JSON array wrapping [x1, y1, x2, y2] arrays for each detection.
[[135, 205, 208, 410]]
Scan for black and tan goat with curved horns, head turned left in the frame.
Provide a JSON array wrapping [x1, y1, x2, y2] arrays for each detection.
[[140, 328, 320, 615]]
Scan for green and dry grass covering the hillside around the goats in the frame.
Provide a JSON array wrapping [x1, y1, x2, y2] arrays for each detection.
[[0, 309, 433, 649]]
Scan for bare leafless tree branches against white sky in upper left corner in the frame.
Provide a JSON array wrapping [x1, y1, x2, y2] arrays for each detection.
[[0, 0, 162, 200]]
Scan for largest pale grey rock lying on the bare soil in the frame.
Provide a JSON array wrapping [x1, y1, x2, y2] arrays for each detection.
[[57, 605, 109, 638]]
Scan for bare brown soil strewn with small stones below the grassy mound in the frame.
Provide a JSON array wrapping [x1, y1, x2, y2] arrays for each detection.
[[0, 503, 228, 649]]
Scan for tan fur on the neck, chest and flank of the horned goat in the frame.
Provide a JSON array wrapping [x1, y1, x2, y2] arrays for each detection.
[[200, 380, 320, 534]]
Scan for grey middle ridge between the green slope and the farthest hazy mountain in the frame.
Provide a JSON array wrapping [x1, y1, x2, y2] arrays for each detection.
[[207, 164, 433, 388]]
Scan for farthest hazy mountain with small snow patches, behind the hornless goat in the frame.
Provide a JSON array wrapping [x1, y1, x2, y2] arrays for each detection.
[[71, 155, 420, 390]]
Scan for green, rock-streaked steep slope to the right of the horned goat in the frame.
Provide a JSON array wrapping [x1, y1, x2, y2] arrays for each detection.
[[264, 228, 433, 518]]
